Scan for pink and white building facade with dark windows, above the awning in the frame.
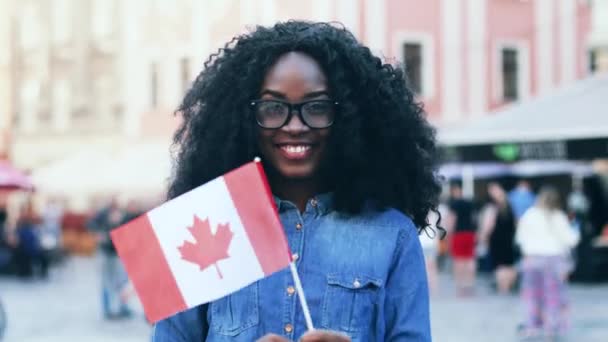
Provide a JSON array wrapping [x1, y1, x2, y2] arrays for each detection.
[[218, 0, 590, 122]]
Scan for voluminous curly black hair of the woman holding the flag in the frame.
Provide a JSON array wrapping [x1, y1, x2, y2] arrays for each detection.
[[168, 21, 441, 229]]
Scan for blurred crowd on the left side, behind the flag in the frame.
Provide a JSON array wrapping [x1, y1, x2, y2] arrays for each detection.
[[0, 192, 157, 319]]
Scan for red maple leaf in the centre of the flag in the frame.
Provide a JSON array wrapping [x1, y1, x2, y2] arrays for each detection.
[[177, 215, 233, 279]]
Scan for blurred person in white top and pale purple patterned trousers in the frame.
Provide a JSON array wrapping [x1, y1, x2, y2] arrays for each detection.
[[515, 187, 580, 337]]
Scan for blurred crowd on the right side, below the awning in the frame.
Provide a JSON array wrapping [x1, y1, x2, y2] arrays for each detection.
[[420, 179, 608, 337]]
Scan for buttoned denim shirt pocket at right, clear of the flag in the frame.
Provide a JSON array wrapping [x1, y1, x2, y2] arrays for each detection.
[[321, 274, 382, 337]]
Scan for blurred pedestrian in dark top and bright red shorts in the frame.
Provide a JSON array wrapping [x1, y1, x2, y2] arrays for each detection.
[[446, 183, 477, 296]]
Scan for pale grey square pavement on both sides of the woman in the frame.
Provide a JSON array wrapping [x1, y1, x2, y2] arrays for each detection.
[[0, 257, 608, 342]]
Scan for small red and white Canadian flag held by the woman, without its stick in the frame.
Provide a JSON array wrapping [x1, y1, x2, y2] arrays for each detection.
[[111, 162, 291, 322]]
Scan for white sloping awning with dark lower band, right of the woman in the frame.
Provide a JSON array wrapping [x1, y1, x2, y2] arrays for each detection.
[[438, 74, 608, 162]]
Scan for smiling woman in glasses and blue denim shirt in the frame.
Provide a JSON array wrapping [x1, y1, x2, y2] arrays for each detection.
[[153, 21, 440, 342]]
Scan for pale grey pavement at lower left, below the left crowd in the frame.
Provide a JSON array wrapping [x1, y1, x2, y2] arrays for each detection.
[[0, 258, 150, 342]]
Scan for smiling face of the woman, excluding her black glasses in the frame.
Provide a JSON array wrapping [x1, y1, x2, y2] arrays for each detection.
[[258, 52, 330, 180]]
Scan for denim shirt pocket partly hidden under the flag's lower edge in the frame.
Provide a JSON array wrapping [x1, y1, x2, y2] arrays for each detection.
[[209, 282, 260, 336]]
